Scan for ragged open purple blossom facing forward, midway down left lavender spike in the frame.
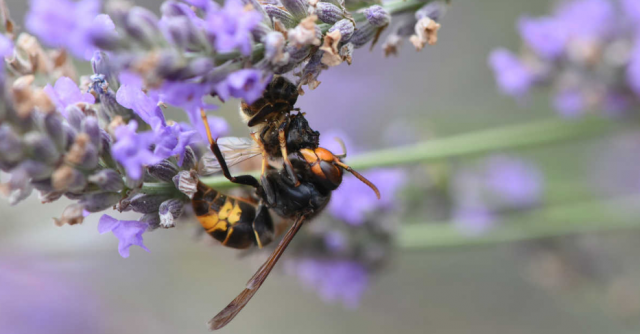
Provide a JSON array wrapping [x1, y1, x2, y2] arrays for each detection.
[[111, 121, 162, 180]]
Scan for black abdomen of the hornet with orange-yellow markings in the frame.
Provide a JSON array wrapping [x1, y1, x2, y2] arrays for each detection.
[[191, 183, 273, 248]]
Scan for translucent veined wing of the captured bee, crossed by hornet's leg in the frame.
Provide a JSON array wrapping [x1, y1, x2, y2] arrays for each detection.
[[198, 137, 261, 175]]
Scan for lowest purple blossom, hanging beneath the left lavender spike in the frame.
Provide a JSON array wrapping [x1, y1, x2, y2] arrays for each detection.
[[98, 215, 149, 258]]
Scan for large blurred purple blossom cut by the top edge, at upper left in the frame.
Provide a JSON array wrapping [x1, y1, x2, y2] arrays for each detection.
[[25, 0, 115, 60]]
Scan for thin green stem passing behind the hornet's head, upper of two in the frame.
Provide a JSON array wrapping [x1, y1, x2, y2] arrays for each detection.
[[201, 118, 611, 188]]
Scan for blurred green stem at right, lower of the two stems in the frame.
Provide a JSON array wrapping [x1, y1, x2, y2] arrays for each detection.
[[397, 195, 640, 249]]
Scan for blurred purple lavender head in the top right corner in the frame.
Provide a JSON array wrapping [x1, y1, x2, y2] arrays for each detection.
[[489, 0, 640, 118]]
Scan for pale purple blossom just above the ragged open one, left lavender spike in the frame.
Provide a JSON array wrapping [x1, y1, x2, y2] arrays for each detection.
[[116, 71, 166, 128]]
